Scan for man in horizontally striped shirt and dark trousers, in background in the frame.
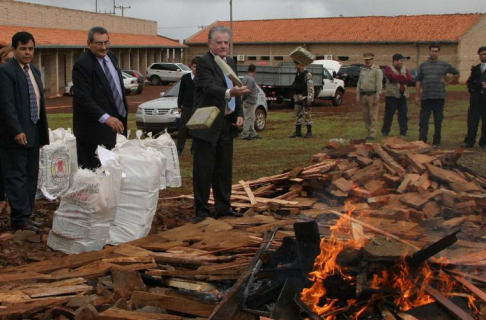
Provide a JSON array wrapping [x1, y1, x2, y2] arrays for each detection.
[[415, 44, 459, 148]]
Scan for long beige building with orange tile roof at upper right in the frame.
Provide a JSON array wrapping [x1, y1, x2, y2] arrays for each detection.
[[184, 13, 486, 81]]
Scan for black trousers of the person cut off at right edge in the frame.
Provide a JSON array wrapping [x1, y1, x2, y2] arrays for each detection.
[[464, 92, 486, 146]]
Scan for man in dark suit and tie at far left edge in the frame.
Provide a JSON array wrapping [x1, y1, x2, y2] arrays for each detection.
[[0, 32, 49, 232]]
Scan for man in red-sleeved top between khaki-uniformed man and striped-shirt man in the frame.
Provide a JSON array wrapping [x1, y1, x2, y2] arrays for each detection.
[[381, 53, 412, 137]]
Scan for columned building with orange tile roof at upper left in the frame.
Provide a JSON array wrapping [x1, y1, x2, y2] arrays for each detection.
[[0, 0, 187, 96]]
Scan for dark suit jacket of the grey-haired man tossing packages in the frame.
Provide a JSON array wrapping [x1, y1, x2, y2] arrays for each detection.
[[191, 52, 243, 143]]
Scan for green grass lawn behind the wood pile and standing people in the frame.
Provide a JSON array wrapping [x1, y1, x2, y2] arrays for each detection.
[[48, 85, 486, 196]]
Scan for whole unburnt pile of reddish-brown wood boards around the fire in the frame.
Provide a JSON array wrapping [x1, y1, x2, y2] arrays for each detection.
[[0, 138, 486, 319]]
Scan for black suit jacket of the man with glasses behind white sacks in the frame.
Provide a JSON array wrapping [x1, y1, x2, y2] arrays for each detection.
[[73, 50, 128, 144]]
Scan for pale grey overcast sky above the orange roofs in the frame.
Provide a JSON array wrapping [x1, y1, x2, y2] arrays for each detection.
[[18, 0, 486, 40]]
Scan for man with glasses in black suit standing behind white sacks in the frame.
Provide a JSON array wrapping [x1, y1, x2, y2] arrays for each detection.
[[73, 27, 128, 169]]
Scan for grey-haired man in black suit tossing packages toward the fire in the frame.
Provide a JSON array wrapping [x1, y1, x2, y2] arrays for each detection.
[[190, 26, 250, 222]]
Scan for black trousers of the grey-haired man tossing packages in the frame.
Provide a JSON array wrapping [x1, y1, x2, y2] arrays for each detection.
[[192, 117, 233, 217]]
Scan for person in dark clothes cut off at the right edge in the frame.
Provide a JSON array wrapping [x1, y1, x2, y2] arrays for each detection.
[[462, 47, 486, 149]]
